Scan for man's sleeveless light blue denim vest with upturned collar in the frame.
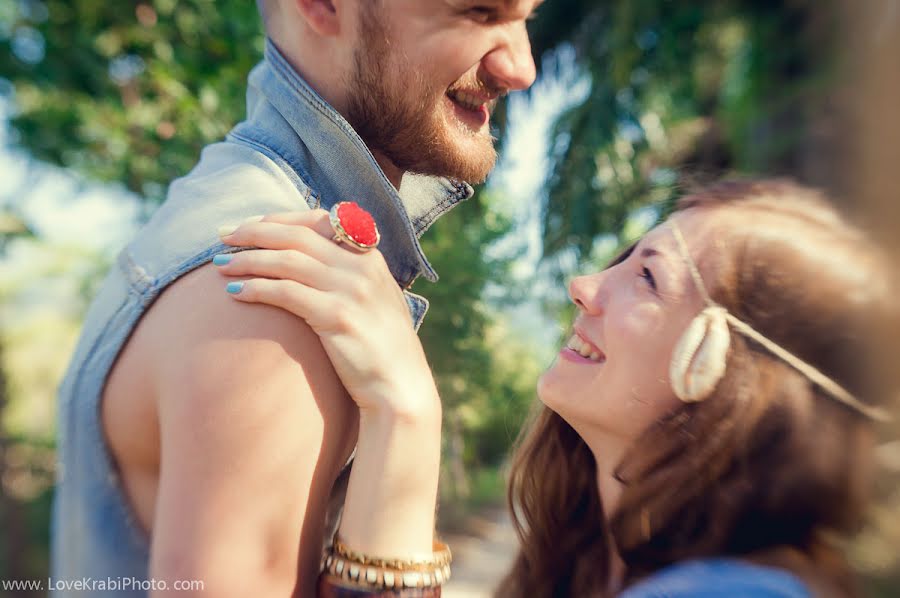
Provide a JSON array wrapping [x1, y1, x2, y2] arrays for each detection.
[[51, 41, 472, 596]]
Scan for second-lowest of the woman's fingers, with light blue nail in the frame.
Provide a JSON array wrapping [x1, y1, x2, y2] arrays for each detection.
[[213, 249, 339, 291]]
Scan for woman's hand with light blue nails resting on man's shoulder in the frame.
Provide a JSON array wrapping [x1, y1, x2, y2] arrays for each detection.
[[213, 210, 440, 416]]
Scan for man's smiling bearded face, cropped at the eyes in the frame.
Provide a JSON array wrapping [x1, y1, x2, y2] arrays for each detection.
[[347, 0, 542, 183]]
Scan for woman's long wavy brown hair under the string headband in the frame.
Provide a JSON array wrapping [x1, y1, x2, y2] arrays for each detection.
[[495, 180, 897, 598]]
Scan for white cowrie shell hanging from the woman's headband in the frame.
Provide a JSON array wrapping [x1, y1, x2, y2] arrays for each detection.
[[669, 306, 731, 403]]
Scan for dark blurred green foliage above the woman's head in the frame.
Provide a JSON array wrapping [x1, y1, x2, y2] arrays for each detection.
[[533, 0, 835, 270]]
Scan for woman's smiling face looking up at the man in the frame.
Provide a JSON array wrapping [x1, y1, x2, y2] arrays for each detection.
[[538, 209, 721, 440]]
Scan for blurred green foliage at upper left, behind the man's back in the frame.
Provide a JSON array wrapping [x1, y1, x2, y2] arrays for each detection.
[[0, 0, 263, 202]]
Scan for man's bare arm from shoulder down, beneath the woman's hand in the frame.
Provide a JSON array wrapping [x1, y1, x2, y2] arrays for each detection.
[[148, 266, 358, 597]]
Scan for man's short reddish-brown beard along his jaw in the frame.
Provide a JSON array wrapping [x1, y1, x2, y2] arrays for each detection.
[[347, 7, 497, 183]]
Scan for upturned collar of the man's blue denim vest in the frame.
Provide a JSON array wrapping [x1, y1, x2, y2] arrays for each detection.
[[232, 39, 473, 287]]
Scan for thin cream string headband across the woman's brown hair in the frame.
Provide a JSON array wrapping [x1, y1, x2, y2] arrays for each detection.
[[666, 220, 892, 422]]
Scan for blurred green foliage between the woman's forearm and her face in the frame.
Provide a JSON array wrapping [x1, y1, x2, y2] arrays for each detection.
[[415, 193, 537, 478]]
